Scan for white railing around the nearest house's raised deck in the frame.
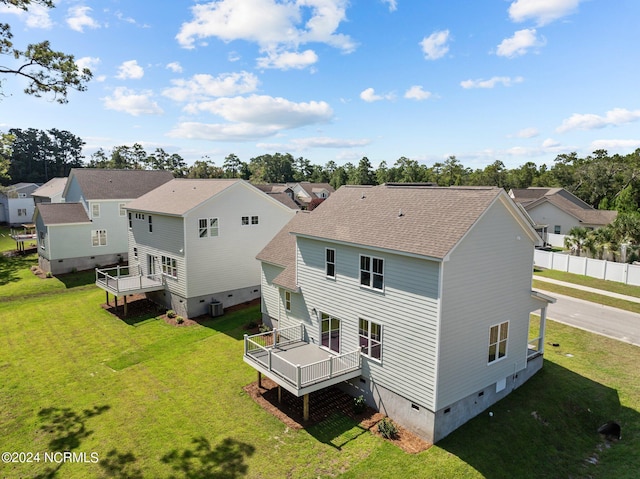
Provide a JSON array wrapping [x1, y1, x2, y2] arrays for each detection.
[[244, 324, 360, 389]]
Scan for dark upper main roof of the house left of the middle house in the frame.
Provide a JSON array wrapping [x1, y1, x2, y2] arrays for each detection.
[[65, 168, 173, 200]]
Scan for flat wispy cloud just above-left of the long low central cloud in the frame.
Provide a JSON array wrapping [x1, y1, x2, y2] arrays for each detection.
[[162, 71, 259, 101]]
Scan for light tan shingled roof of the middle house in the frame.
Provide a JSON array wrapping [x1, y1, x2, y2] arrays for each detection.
[[127, 179, 243, 216]]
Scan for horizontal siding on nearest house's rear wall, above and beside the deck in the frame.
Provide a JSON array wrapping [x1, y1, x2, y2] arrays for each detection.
[[291, 237, 440, 407]]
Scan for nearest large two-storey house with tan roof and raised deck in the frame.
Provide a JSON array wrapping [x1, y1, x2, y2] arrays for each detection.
[[244, 185, 554, 442]]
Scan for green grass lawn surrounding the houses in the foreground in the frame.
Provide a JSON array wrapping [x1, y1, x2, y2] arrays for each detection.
[[0, 257, 640, 479]]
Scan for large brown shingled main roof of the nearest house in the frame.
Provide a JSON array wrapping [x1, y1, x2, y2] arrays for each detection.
[[292, 185, 526, 259]]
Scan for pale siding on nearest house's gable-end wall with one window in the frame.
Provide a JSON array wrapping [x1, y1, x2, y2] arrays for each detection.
[[436, 201, 540, 409]]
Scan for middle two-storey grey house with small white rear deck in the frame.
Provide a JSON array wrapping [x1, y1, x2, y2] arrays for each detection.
[[96, 179, 296, 317]]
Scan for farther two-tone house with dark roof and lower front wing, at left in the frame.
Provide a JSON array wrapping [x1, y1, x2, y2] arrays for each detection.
[[33, 168, 173, 274]]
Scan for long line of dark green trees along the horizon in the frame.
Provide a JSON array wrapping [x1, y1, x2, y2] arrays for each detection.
[[0, 128, 640, 212]]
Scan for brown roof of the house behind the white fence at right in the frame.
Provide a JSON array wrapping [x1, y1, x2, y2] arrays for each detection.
[[509, 187, 618, 226]]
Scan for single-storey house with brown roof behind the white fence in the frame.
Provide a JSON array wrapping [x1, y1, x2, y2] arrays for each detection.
[[509, 187, 617, 242]]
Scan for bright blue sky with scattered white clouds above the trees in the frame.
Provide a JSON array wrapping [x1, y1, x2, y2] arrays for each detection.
[[0, 0, 640, 169]]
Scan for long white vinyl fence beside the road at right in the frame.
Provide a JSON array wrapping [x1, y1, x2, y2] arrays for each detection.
[[533, 250, 640, 286]]
